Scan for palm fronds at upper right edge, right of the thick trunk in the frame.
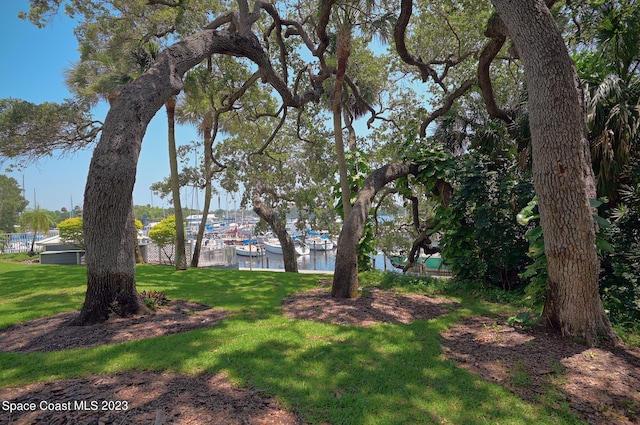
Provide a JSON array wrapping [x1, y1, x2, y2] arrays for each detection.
[[582, 0, 640, 204]]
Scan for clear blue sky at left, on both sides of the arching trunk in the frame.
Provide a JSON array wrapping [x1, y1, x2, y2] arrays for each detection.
[[0, 0, 210, 210]]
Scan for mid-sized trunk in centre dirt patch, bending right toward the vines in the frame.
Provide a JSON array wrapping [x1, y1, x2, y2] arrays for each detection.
[[331, 163, 418, 298]]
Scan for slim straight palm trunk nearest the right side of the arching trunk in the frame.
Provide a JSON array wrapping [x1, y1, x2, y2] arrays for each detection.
[[165, 96, 187, 270]]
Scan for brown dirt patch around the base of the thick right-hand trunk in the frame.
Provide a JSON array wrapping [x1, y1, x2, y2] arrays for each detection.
[[442, 317, 640, 425]]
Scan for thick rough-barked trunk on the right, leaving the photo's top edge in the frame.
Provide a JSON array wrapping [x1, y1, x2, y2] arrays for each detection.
[[492, 0, 615, 345]]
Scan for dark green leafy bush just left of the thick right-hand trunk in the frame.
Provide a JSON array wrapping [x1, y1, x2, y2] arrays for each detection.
[[440, 154, 534, 289]]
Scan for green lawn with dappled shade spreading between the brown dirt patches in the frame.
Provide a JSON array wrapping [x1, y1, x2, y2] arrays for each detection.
[[0, 262, 580, 425]]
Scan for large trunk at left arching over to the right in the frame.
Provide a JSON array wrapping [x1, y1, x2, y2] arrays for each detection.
[[75, 30, 284, 324]]
